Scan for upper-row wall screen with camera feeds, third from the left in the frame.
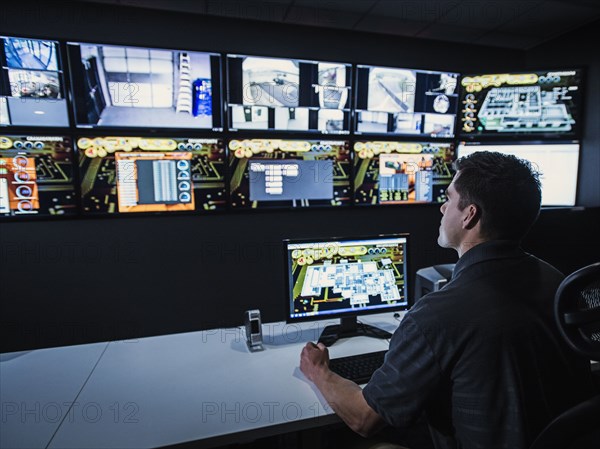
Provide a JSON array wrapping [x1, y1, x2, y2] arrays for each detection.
[[227, 55, 352, 134]]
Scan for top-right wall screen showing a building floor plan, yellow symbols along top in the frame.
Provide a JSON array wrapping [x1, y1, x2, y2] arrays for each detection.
[[460, 70, 582, 137]]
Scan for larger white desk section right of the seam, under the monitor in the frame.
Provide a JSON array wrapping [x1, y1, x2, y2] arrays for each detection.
[[48, 313, 398, 449]]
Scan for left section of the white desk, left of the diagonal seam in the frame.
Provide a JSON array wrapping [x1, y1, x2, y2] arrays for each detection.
[[0, 343, 108, 449]]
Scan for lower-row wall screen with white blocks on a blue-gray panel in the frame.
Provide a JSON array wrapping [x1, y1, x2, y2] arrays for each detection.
[[229, 139, 352, 209]]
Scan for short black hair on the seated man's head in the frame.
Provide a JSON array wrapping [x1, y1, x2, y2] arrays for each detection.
[[454, 151, 542, 240]]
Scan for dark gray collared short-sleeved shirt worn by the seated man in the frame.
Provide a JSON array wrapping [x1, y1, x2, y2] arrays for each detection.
[[363, 241, 591, 449]]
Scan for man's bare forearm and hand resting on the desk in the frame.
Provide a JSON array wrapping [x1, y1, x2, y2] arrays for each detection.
[[300, 342, 385, 437]]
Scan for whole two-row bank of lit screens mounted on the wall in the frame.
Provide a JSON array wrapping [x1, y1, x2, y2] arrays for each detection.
[[0, 36, 584, 219]]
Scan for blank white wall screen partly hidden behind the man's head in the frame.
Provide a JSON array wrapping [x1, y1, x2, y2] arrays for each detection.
[[458, 140, 579, 206]]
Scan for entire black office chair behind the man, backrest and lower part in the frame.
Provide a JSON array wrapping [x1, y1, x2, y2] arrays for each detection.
[[530, 263, 600, 449]]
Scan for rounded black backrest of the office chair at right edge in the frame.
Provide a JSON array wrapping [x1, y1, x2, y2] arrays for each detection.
[[554, 262, 600, 360]]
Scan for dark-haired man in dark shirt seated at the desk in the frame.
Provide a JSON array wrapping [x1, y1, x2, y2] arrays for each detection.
[[300, 152, 591, 449]]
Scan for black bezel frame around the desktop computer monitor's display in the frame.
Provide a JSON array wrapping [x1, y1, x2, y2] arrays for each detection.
[[282, 232, 412, 324]]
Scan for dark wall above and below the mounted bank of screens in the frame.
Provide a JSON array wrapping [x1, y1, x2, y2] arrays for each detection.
[[0, 2, 599, 352]]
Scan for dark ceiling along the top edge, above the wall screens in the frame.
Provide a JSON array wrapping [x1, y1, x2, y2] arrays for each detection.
[[76, 0, 600, 50]]
